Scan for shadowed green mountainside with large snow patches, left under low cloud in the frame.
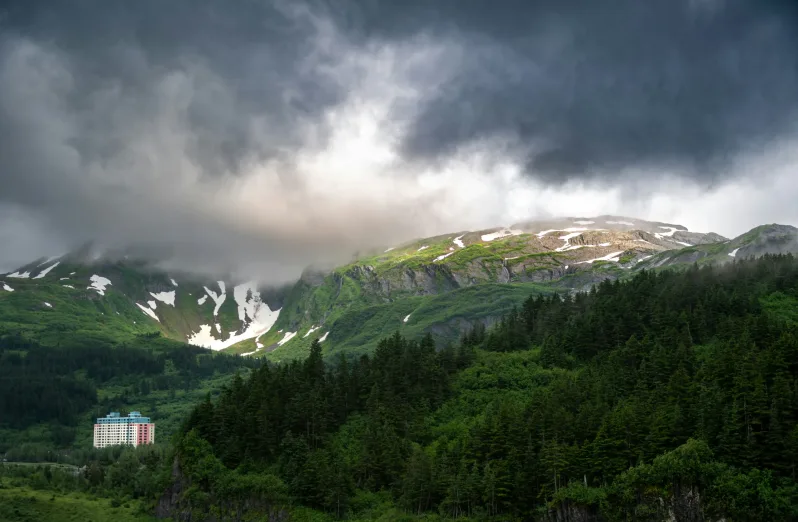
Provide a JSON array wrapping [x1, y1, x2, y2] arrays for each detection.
[[0, 252, 284, 350]]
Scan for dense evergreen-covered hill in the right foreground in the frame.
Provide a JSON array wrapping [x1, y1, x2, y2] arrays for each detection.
[[177, 256, 798, 520]]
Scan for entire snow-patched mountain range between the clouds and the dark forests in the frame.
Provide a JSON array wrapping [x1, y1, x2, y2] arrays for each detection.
[[0, 216, 798, 361]]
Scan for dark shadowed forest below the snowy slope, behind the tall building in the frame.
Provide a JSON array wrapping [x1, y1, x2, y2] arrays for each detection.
[[0, 331, 260, 451]]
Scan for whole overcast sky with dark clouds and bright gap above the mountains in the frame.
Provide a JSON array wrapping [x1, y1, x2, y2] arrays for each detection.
[[0, 0, 798, 282]]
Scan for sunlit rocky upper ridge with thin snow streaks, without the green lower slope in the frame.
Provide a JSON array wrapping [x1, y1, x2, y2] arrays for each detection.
[[326, 216, 725, 301]]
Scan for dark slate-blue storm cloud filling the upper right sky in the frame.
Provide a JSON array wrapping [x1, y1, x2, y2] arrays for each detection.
[[358, 0, 798, 182]]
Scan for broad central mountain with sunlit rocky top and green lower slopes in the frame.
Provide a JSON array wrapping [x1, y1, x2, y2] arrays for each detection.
[[250, 216, 726, 361]]
